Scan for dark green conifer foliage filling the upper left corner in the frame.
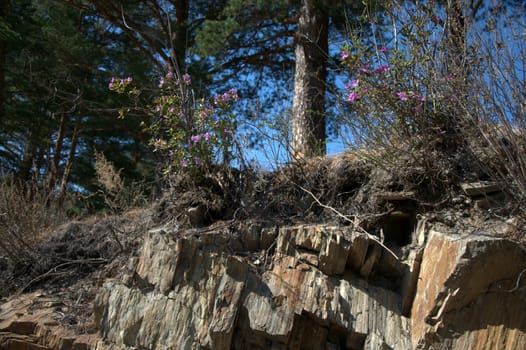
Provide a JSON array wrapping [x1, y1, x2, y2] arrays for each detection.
[[0, 0, 155, 208]]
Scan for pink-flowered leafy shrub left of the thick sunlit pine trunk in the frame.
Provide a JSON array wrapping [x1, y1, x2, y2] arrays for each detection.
[[109, 72, 239, 175]]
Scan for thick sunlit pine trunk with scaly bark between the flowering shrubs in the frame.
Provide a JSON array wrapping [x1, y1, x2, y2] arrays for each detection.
[[291, 0, 329, 159]]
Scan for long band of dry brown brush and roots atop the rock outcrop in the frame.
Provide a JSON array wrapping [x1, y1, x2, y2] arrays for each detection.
[[0, 122, 525, 326]]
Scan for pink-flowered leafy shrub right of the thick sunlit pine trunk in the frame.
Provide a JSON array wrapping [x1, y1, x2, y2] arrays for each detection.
[[340, 2, 464, 152]]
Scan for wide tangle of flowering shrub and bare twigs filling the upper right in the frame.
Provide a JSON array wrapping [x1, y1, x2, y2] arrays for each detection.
[[341, 1, 526, 213]]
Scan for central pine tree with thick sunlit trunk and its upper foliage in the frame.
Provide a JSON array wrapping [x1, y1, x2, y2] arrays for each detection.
[[195, 0, 372, 158]]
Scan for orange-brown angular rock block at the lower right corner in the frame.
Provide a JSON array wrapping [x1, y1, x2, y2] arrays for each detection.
[[411, 230, 526, 350]]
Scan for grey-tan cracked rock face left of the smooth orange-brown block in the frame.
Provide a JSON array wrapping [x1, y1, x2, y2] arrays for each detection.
[[95, 226, 411, 349]]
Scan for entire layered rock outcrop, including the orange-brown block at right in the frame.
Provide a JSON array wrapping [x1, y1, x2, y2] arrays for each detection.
[[95, 221, 526, 349]]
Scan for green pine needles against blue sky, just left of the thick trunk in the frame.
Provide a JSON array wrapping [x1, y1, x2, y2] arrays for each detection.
[[191, 0, 295, 78]]
